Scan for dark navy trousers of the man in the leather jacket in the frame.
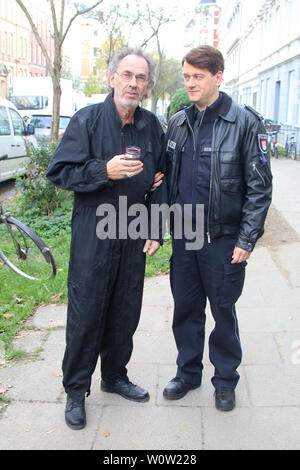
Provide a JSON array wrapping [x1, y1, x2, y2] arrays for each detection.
[[170, 236, 247, 388]]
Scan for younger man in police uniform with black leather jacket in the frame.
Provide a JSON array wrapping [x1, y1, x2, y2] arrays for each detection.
[[163, 46, 272, 411]]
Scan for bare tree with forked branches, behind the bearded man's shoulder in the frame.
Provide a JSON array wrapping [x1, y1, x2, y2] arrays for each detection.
[[16, 0, 103, 142]]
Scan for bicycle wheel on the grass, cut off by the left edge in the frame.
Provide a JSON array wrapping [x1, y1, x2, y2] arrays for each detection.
[[0, 217, 56, 281]]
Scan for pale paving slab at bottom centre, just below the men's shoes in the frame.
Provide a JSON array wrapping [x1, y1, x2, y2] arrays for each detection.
[[94, 406, 202, 451]]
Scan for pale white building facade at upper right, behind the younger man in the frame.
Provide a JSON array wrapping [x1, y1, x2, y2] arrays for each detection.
[[218, 0, 300, 126]]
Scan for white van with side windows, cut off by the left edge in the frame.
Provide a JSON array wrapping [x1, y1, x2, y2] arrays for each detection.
[[0, 97, 37, 182]]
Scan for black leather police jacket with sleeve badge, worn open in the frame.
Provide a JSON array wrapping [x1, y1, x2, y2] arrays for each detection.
[[165, 93, 272, 251]]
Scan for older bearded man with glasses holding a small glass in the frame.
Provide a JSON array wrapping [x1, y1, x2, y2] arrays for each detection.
[[47, 49, 164, 429]]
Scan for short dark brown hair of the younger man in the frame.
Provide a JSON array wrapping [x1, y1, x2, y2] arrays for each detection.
[[182, 45, 224, 75]]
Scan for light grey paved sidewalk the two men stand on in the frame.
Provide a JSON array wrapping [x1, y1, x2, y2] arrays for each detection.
[[0, 160, 300, 451]]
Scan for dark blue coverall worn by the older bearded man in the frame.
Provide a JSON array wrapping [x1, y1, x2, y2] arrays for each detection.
[[47, 95, 163, 402]]
